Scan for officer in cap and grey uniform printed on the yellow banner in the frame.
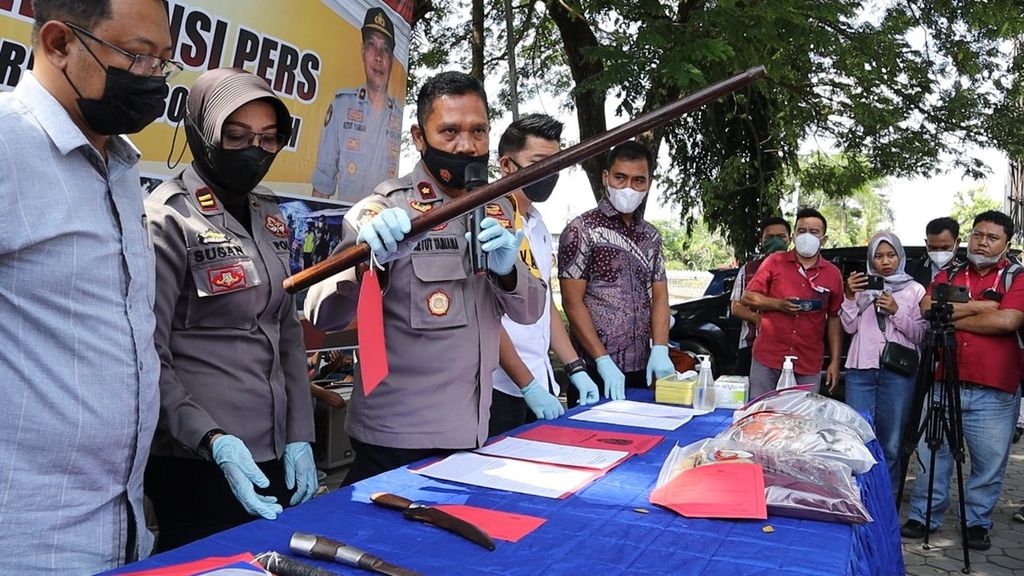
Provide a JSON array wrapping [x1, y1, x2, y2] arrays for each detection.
[[312, 7, 401, 203]]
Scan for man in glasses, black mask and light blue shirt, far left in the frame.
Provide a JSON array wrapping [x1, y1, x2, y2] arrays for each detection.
[[0, 0, 179, 574]]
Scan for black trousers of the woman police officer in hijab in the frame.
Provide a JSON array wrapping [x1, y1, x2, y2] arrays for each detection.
[[145, 456, 294, 552]]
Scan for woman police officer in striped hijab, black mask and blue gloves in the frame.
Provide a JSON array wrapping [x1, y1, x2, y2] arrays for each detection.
[[145, 69, 317, 550]]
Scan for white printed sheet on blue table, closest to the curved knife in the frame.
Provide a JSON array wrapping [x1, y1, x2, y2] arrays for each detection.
[[412, 452, 602, 498]]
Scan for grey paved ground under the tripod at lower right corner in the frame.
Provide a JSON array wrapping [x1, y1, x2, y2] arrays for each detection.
[[901, 441, 1024, 576]]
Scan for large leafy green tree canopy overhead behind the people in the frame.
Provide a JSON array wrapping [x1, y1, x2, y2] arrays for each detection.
[[403, 0, 1024, 252]]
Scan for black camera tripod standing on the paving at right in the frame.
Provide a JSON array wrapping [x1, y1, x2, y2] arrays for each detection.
[[896, 284, 971, 574]]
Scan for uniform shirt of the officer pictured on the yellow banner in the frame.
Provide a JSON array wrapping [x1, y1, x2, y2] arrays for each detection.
[[312, 86, 401, 204]]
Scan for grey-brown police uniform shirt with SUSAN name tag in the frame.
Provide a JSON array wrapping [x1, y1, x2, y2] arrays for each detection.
[[145, 163, 313, 462]]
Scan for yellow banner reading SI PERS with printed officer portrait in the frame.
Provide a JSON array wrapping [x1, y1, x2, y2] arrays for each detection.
[[0, 0, 412, 202]]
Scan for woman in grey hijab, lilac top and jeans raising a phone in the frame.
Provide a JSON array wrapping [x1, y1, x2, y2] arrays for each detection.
[[840, 232, 925, 486]]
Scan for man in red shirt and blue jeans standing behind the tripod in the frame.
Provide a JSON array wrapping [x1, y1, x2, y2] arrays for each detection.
[[900, 210, 1024, 550]]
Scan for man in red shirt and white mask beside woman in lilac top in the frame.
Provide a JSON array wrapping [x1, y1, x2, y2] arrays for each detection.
[[740, 208, 843, 398]]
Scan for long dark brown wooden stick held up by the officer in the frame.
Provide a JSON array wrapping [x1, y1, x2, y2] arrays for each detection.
[[285, 66, 765, 294]]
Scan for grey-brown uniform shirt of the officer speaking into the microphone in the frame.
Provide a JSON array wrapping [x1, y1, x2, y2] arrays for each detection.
[[305, 162, 547, 449]]
